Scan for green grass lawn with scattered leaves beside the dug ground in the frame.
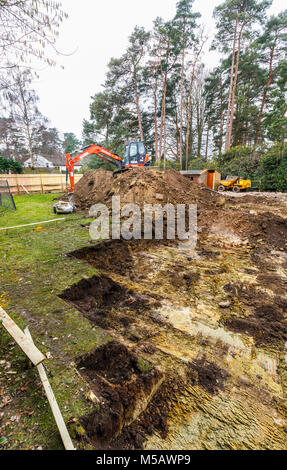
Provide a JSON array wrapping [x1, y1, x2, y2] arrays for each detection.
[[0, 194, 109, 450]]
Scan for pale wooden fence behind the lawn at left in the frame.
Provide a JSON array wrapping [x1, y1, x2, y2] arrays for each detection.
[[0, 173, 83, 194]]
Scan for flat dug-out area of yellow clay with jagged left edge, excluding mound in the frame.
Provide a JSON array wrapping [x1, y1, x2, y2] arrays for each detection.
[[61, 234, 286, 449]]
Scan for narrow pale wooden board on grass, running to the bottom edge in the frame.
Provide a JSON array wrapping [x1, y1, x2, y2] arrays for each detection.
[[24, 327, 75, 450]]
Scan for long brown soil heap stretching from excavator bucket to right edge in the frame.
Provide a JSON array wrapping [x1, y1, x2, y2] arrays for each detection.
[[74, 168, 287, 251]]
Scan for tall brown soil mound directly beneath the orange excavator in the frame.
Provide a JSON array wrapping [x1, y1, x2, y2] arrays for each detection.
[[71, 168, 220, 210]]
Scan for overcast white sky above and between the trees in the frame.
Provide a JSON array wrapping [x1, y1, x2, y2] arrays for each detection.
[[34, 0, 286, 137]]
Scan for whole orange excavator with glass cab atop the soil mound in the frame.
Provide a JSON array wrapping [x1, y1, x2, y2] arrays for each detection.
[[66, 142, 151, 193]]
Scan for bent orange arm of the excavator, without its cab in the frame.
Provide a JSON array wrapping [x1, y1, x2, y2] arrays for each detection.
[[66, 144, 124, 193]]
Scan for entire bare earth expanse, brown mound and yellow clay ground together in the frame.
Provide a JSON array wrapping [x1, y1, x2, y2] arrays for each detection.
[[62, 170, 287, 450]]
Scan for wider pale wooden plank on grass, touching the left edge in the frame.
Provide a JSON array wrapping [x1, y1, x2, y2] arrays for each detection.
[[0, 307, 45, 366]]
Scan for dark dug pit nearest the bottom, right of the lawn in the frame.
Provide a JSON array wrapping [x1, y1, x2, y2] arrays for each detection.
[[77, 341, 164, 448]]
